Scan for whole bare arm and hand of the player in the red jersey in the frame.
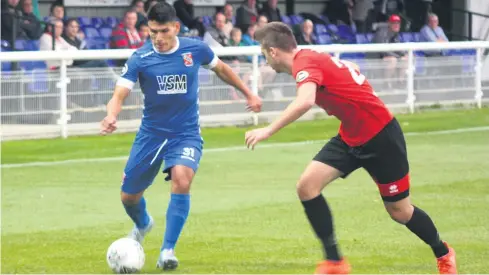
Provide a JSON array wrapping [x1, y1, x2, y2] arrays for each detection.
[[245, 82, 317, 149]]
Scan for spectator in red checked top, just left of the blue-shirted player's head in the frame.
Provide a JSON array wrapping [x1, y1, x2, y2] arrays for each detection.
[[109, 10, 143, 66]]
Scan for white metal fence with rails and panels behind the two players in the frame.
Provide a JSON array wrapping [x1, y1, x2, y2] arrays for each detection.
[[0, 42, 489, 140]]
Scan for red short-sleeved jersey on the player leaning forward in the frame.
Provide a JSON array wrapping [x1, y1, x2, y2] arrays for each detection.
[[292, 50, 393, 147]]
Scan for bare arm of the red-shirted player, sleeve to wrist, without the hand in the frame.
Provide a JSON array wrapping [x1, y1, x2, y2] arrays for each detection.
[[267, 82, 317, 136]]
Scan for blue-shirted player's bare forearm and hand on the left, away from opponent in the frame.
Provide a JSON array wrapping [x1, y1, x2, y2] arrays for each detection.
[[100, 85, 131, 135]]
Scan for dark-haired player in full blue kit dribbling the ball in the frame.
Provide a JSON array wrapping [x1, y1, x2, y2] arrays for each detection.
[[96, 2, 261, 270]]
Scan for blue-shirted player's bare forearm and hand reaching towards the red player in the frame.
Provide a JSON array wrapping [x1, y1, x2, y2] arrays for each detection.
[[212, 60, 262, 112]]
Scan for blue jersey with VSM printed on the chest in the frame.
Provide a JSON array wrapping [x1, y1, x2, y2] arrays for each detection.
[[117, 38, 218, 137]]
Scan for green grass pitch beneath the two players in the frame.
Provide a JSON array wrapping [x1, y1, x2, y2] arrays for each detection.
[[1, 108, 489, 274]]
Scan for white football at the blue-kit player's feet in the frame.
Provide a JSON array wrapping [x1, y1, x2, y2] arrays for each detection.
[[107, 238, 145, 274]]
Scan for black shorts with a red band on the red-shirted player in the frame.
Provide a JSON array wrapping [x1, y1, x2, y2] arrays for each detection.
[[314, 118, 409, 202]]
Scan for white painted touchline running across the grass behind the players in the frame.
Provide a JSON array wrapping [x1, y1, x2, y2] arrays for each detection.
[[1, 126, 489, 168]]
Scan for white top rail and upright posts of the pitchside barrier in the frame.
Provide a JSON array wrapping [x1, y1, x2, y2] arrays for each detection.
[[0, 41, 489, 138]]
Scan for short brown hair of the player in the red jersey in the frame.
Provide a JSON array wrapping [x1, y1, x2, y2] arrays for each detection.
[[255, 22, 297, 52]]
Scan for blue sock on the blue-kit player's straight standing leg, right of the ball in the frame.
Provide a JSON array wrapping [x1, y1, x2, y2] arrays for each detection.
[[161, 194, 190, 250]]
